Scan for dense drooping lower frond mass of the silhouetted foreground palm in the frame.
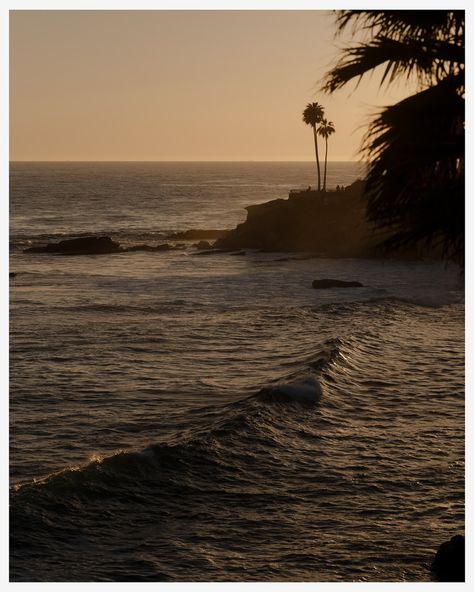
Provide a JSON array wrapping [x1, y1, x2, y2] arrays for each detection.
[[365, 75, 465, 261]]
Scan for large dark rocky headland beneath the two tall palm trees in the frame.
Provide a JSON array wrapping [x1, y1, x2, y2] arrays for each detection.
[[214, 180, 441, 259]]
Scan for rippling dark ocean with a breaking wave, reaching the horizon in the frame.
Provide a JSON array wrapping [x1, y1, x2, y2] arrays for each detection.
[[10, 162, 464, 582]]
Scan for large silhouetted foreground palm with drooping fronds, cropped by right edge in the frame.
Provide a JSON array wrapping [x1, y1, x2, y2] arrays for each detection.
[[324, 10, 465, 263]]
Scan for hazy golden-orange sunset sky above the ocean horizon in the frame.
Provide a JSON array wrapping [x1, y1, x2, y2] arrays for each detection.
[[10, 10, 422, 161]]
